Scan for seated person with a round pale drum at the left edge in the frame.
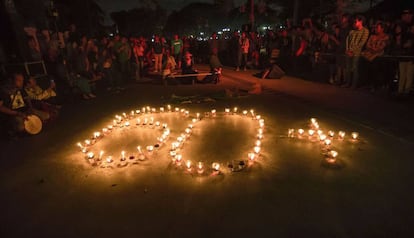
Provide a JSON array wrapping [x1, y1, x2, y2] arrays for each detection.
[[0, 74, 49, 134]]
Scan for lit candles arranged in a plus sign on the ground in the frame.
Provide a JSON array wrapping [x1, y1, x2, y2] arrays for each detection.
[[288, 118, 359, 164]]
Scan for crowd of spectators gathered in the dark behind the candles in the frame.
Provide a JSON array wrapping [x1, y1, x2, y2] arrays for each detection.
[[0, 10, 414, 139]]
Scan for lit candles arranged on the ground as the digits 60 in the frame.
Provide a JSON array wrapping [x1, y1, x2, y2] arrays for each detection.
[[77, 105, 264, 174]]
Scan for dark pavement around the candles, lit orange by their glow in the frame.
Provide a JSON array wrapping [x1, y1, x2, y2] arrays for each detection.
[[0, 65, 414, 237]]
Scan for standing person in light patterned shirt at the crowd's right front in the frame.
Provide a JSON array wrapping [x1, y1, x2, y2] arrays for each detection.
[[343, 15, 369, 88]]
